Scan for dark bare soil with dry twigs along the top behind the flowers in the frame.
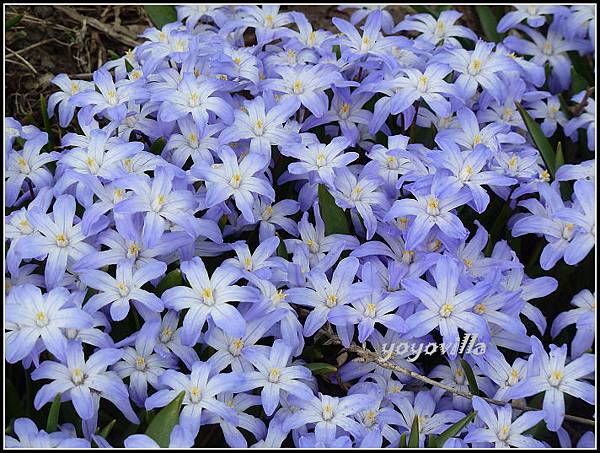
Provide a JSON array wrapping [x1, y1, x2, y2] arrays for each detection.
[[4, 5, 407, 121]]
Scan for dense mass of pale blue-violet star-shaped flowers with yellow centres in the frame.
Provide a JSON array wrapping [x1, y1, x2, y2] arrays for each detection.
[[5, 5, 596, 448]]
